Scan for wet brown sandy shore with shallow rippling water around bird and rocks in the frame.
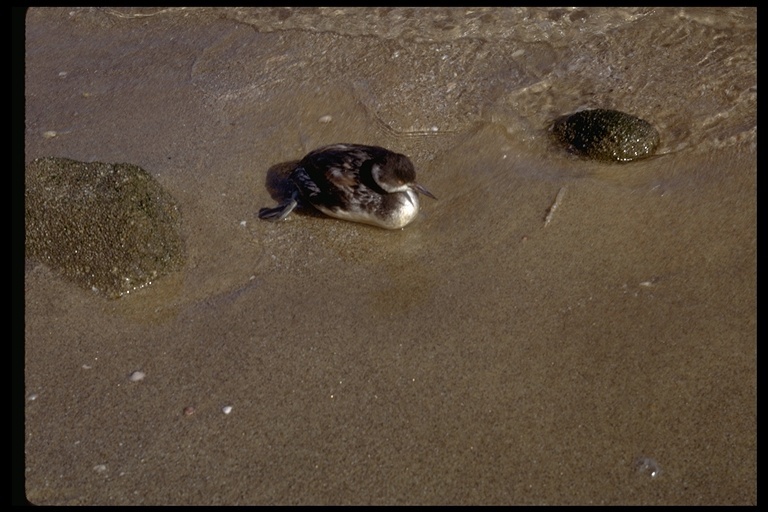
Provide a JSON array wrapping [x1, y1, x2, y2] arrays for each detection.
[[22, 9, 757, 505]]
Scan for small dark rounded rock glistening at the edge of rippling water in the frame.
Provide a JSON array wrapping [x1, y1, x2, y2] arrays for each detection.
[[552, 109, 659, 162]]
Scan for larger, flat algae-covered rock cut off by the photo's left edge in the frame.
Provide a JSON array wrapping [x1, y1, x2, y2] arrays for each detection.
[[24, 157, 184, 298]]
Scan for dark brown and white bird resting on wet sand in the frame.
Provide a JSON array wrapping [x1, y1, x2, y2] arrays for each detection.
[[259, 143, 437, 229]]
